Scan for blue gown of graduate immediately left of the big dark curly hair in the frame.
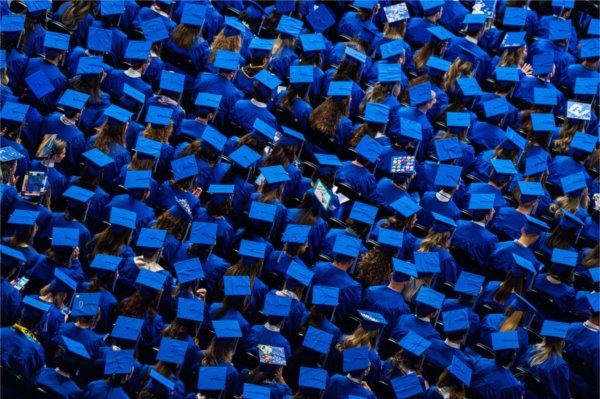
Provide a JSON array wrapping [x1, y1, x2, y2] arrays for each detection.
[[311, 262, 362, 320]]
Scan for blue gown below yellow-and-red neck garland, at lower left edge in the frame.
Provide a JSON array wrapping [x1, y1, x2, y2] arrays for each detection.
[[0, 327, 46, 382]]
